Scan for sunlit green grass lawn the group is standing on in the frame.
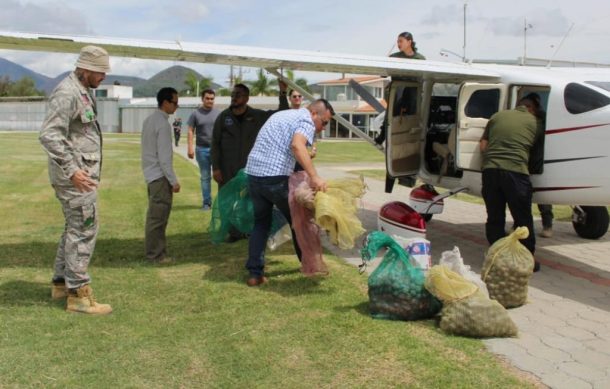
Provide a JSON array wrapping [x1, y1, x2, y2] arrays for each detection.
[[0, 133, 531, 388]]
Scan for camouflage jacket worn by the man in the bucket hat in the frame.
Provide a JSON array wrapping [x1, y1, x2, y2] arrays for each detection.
[[39, 72, 102, 187]]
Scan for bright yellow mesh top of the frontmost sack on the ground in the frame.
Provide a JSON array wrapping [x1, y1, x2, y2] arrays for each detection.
[[424, 265, 479, 303]]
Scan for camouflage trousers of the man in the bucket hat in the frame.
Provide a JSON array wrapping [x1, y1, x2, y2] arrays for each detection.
[[53, 187, 98, 289]]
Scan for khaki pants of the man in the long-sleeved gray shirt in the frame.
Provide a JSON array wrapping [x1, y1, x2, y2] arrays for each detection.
[[145, 177, 174, 261]]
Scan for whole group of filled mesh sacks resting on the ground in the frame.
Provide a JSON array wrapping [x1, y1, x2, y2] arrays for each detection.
[[361, 227, 534, 338]]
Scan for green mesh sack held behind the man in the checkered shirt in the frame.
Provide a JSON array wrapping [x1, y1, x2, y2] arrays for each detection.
[[208, 169, 286, 243]]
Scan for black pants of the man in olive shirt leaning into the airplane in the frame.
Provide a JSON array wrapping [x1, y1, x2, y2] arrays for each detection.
[[482, 169, 536, 254]]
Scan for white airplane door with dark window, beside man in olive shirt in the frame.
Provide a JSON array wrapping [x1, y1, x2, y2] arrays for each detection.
[[455, 82, 507, 171]]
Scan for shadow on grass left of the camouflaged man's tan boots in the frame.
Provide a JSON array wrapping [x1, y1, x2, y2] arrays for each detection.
[[0, 279, 60, 307]]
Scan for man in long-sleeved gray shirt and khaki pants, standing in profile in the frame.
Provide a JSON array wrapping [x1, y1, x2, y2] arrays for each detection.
[[142, 88, 180, 264]]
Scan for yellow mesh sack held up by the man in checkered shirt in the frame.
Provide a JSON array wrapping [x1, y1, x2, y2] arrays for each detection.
[[314, 177, 366, 249]]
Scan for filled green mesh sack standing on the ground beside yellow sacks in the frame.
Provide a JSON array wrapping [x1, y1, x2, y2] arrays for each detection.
[[361, 231, 441, 320]]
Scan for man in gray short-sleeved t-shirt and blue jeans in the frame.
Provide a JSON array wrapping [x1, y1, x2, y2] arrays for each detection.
[[187, 89, 220, 211]]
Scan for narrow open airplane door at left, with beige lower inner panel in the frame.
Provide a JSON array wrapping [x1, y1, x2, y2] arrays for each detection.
[[386, 81, 424, 177]]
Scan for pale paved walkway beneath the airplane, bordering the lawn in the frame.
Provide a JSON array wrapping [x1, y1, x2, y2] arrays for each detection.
[[177, 142, 610, 389]]
